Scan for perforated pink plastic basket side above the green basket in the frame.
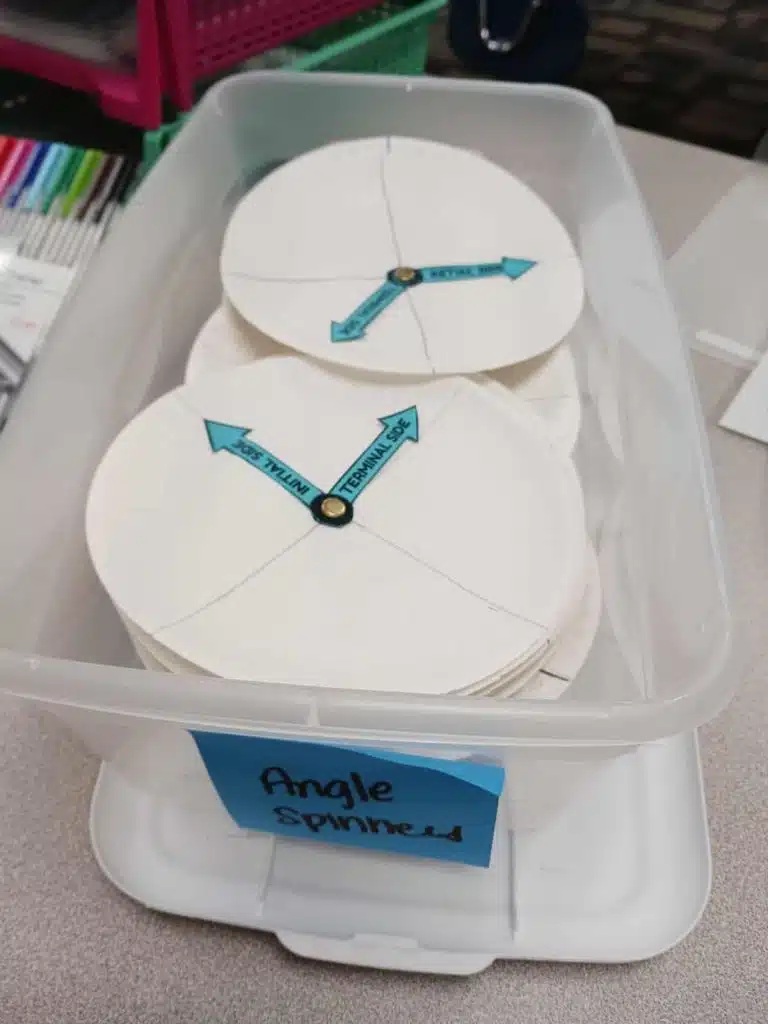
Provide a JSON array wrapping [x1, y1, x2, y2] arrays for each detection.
[[158, 0, 379, 111]]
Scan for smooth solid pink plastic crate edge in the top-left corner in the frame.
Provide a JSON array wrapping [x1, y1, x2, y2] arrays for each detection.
[[0, 0, 165, 128]]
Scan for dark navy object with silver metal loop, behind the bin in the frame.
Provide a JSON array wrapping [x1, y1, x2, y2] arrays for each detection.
[[449, 0, 589, 82]]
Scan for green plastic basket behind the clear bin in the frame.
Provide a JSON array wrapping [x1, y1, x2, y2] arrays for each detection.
[[140, 0, 446, 177]]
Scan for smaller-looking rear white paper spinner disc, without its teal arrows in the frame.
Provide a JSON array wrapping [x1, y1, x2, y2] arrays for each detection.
[[221, 138, 584, 374]]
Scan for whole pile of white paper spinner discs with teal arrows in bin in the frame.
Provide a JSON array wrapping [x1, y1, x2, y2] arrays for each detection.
[[86, 137, 601, 699]]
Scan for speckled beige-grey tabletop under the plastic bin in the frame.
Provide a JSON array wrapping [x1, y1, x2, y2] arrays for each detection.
[[0, 131, 768, 1024]]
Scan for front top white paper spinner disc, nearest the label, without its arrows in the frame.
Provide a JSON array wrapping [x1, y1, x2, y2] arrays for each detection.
[[86, 357, 585, 693]]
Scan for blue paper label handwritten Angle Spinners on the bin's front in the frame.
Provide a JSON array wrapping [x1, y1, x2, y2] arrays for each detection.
[[193, 732, 504, 867]]
